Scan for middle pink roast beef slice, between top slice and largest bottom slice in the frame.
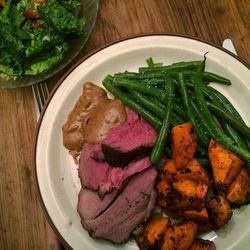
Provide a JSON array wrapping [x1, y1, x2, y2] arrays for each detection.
[[79, 143, 151, 195]]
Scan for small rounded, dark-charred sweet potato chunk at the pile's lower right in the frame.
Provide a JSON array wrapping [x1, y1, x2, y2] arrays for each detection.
[[207, 195, 232, 228]]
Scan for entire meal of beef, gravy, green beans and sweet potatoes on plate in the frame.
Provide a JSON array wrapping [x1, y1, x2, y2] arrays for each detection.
[[63, 58, 250, 250]]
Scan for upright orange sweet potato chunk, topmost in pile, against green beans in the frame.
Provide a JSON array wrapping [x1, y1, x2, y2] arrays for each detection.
[[171, 122, 197, 169]]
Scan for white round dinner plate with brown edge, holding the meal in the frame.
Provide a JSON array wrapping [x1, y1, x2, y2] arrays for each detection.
[[35, 34, 250, 250]]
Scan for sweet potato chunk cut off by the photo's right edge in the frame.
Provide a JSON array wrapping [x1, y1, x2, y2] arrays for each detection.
[[226, 168, 250, 205]]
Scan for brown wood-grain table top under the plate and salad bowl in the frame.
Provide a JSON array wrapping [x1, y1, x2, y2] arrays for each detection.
[[0, 0, 250, 250]]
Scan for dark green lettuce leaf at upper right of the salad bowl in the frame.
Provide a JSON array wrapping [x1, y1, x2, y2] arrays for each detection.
[[37, 0, 86, 35]]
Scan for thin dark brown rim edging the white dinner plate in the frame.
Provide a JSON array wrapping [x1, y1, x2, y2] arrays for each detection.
[[32, 32, 250, 249]]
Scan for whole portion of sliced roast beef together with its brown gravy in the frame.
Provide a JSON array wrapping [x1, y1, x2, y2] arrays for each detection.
[[62, 83, 157, 243]]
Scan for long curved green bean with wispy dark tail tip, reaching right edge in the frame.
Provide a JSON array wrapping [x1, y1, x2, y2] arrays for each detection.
[[194, 60, 250, 167]]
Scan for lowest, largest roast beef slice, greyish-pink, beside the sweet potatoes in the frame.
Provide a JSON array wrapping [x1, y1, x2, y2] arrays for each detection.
[[78, 167, 156, 243]]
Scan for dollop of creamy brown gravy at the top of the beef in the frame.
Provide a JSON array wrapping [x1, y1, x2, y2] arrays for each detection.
[[62, 82, 126, 152]]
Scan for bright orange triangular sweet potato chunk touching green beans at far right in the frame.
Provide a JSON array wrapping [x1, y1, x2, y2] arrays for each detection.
[[208, 139, 243, 193]]
